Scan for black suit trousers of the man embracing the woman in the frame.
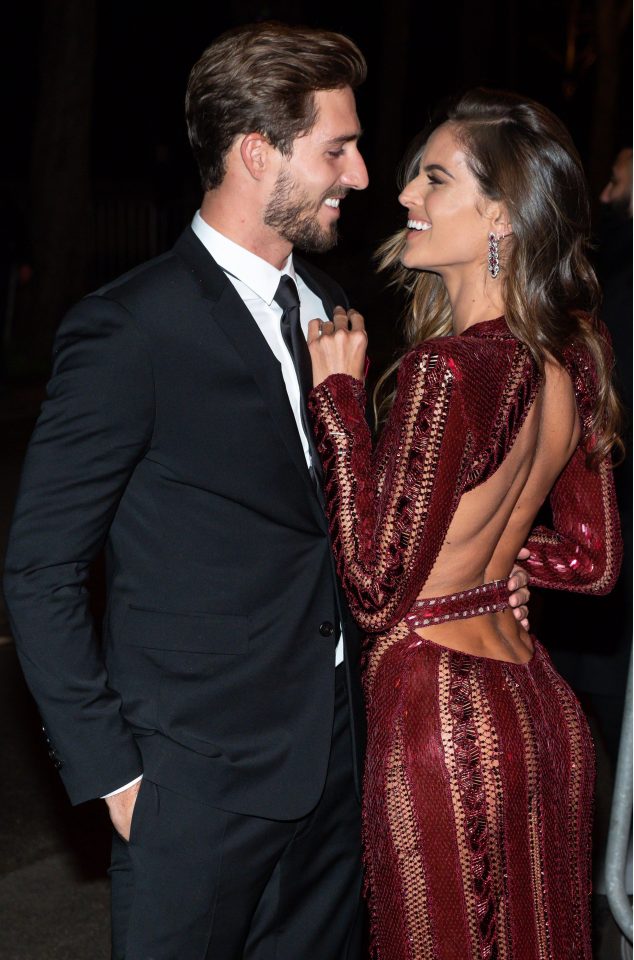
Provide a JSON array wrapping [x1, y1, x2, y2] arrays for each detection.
[[110, 667, 364, 960]]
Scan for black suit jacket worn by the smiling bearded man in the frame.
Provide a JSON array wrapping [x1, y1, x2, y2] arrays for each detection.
[[5, 229, 363, 819]]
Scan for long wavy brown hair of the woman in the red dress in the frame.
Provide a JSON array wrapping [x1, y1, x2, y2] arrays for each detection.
[[375, 89, 622, 464]]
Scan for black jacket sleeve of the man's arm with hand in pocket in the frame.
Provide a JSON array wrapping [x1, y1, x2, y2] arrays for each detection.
[[4, 296, 154, 803]]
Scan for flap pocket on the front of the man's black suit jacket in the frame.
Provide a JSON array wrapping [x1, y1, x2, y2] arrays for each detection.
[[122, 604, 249, 656]]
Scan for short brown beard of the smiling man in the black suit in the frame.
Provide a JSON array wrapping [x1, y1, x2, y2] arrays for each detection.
[[264, 170, 345, 253]]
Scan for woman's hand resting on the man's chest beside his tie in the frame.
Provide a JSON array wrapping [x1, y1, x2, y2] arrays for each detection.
[[308, 307, 368, 387]]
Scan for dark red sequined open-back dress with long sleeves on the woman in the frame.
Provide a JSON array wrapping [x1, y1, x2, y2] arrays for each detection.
[[310, 319, 621, 960]]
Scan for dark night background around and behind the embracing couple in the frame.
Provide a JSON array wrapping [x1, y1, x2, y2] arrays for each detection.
[[0, 0, 632, 960]]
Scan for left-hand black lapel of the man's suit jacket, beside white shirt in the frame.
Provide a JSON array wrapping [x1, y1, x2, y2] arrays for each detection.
[[174, 228, 325, 526]]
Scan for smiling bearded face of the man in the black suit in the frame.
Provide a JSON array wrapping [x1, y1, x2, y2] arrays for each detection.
[[264, 87, 368, 252]]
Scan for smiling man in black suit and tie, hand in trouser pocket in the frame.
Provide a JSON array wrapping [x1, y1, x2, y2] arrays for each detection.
[[6, 24, 524, 960]]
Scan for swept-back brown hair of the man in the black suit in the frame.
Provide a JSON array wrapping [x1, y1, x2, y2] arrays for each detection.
[[185, 22, 367, 190]]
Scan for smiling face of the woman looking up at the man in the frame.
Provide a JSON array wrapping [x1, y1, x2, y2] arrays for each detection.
[[399, 123, 496, 277]]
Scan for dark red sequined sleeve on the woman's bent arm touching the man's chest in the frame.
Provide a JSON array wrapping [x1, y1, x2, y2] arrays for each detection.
[[309, 343, 469, 633]]
